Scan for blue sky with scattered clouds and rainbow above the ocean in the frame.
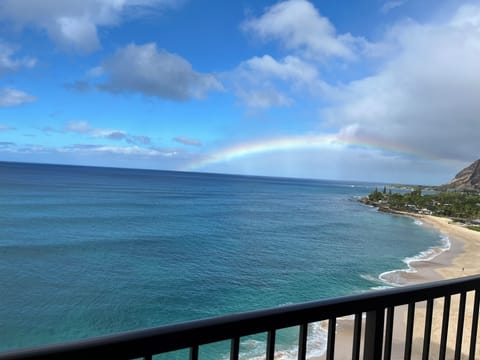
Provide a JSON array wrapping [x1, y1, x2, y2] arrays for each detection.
[[0, 0, 480, 184]]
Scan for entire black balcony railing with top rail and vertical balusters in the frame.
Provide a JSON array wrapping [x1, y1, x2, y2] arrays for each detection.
[[0, 275, 480, 360]]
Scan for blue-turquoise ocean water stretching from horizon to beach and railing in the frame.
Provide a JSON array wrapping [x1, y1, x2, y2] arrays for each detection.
[[0, 162, 448, 359]]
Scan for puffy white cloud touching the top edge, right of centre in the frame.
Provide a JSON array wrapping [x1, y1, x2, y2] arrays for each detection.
[[242, 0, 362, 59]]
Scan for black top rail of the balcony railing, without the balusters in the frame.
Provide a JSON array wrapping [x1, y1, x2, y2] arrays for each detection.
[[0, 275, 480, 360]]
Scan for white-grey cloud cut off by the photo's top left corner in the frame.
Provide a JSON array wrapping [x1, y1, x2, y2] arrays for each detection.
[[0, 0, 181, 53]]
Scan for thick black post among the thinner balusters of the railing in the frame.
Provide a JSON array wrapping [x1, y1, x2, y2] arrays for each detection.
[[363, 309, 385, 360]]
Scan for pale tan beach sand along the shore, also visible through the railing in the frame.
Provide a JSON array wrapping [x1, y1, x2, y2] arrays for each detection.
[[317, 214, 480, 359]]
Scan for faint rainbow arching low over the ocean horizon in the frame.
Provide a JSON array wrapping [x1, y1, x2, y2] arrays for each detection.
[[181, 135, 432, 171]]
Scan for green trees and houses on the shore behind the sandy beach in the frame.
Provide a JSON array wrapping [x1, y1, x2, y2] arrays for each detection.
[[368, 187, 480, 220]]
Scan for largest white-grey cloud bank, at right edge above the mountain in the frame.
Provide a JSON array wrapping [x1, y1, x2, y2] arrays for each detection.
[[323, 5, 480, 160]]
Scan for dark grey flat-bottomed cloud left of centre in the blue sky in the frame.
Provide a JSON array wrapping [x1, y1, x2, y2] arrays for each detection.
[[99, 43, 223, 101]]
